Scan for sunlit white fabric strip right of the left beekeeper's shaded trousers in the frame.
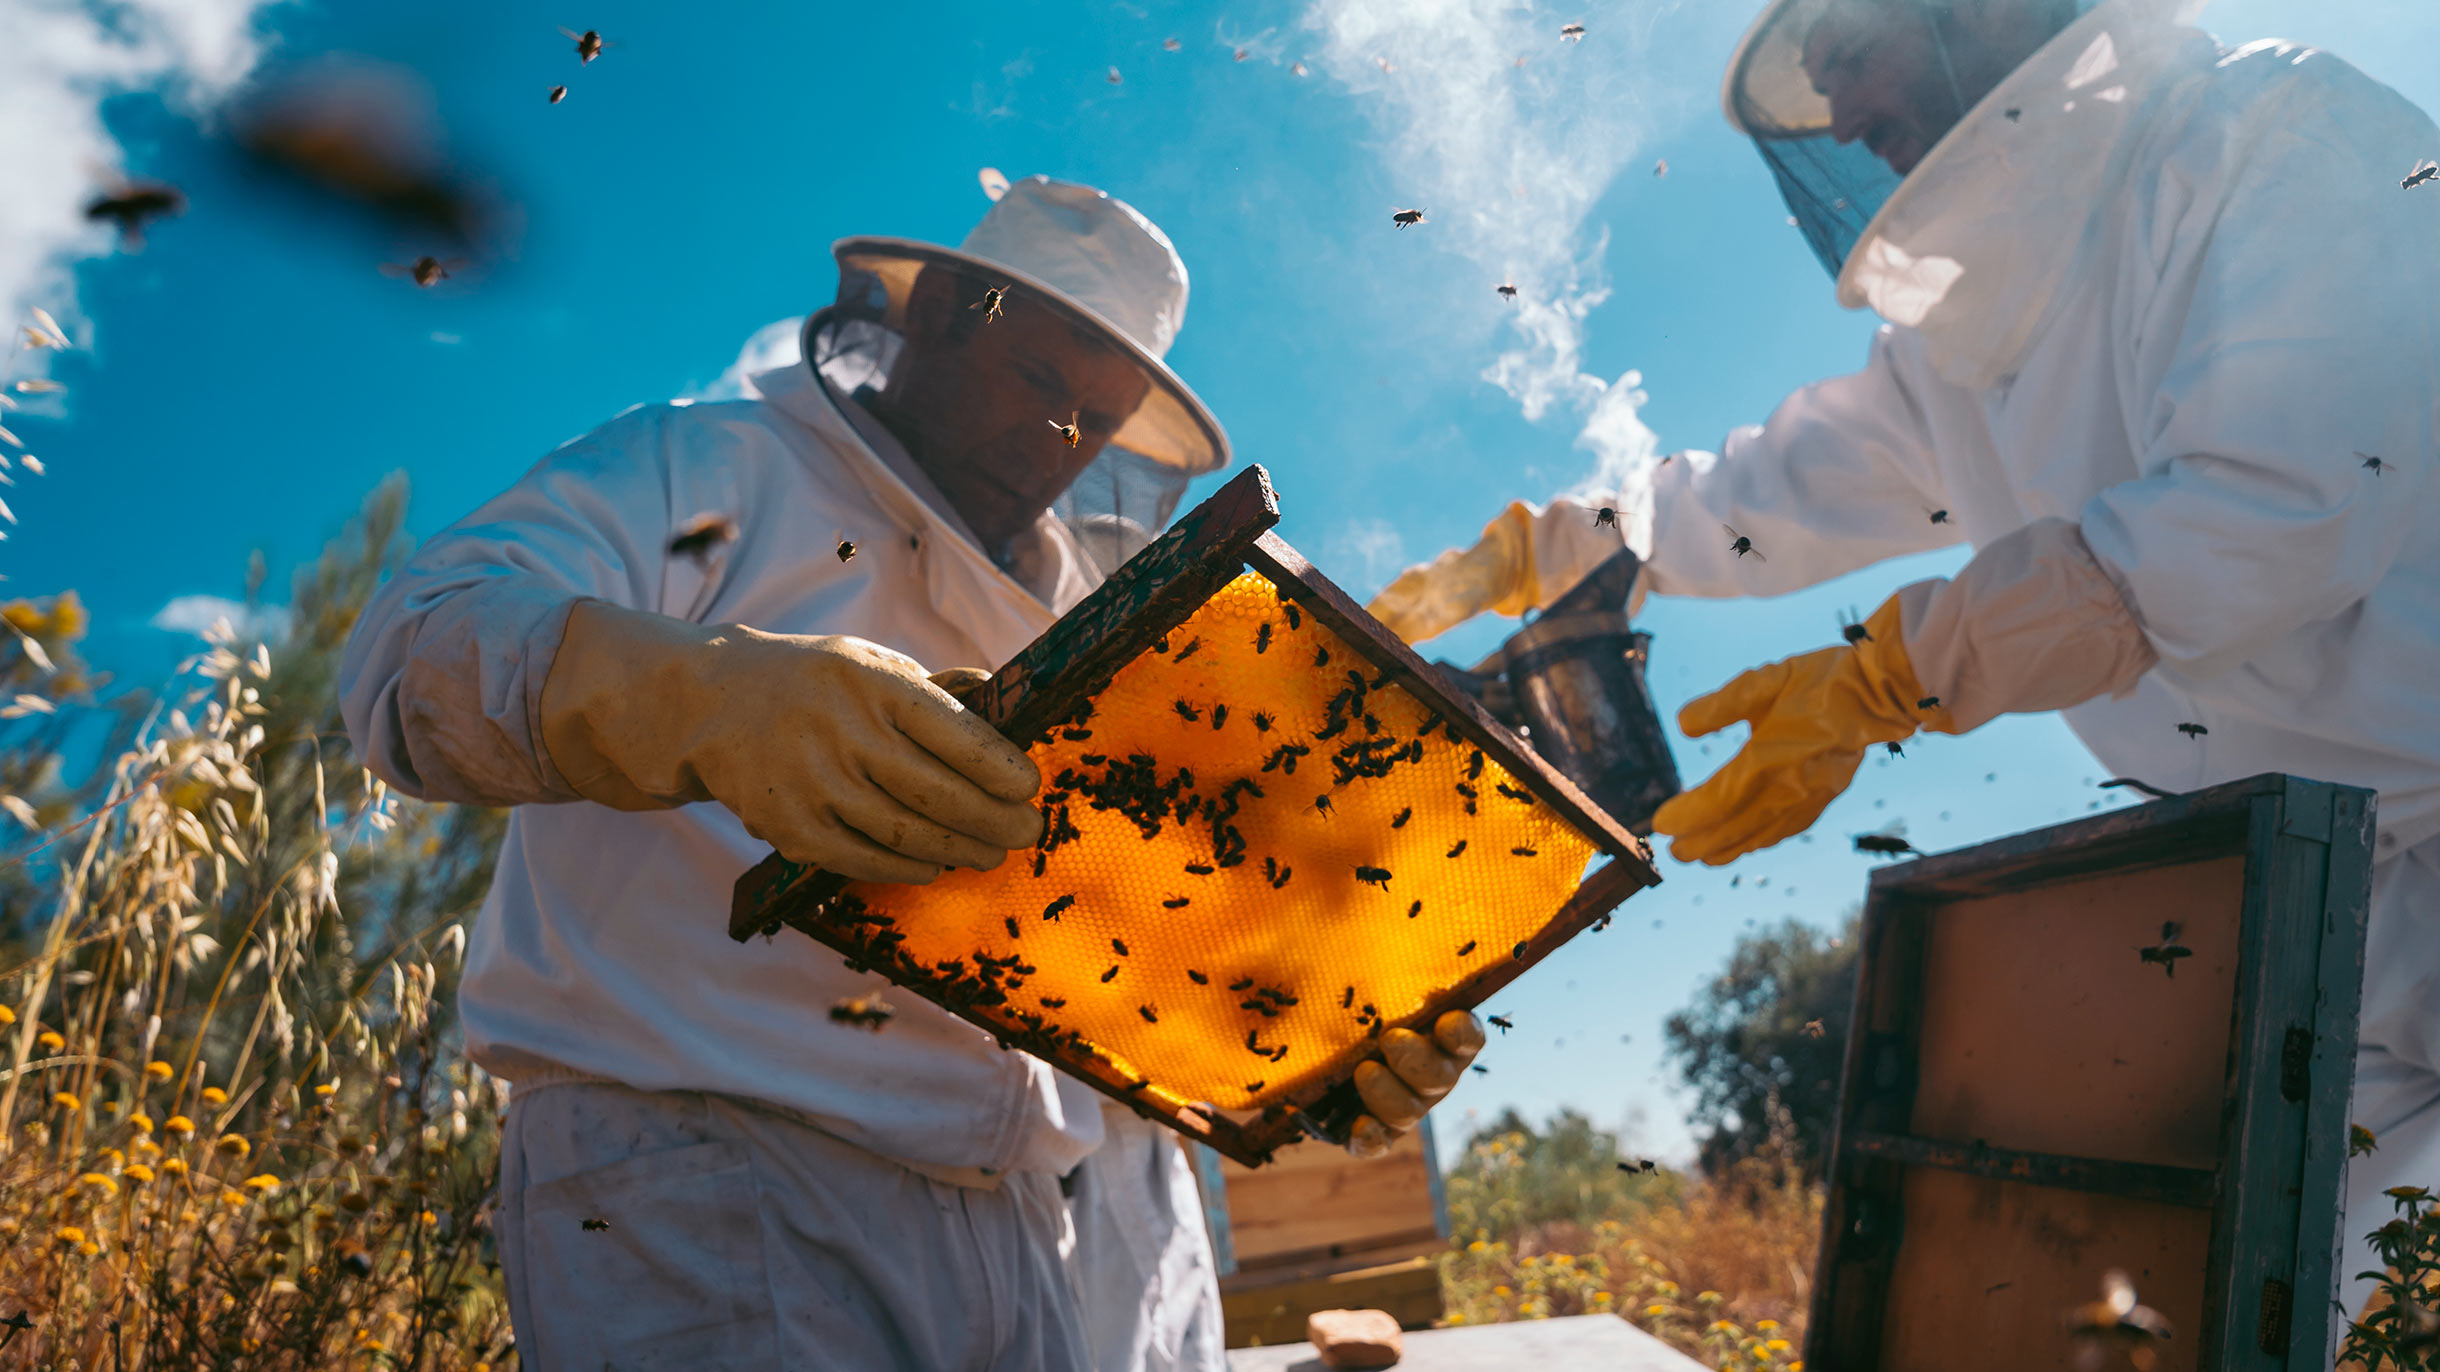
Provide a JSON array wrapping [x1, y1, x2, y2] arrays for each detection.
[[1069, 1106, 1227, 1372]]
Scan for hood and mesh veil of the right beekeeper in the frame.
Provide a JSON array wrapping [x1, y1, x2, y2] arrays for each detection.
[[1720, 0, 2213, 386]]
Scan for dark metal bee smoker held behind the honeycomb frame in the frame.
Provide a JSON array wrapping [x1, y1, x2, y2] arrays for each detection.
[[1435, 549, 1679, 837]]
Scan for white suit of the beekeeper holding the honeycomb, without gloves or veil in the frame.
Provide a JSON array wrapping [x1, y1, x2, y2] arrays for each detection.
[[342, 178, 1220, 1372]]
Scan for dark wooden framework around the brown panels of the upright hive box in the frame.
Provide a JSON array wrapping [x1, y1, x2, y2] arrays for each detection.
[[1806, 774, 2374, 1372]]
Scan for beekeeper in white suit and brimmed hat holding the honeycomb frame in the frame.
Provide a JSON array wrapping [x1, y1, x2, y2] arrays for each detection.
[[342, 178, 1481, 1372]]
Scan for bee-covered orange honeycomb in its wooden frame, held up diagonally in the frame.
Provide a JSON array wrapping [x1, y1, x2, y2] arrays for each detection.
[[730, 466, 1659, 1167]]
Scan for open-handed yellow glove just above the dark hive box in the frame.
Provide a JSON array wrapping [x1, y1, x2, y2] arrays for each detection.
[[1652, 596, 1957, 867]]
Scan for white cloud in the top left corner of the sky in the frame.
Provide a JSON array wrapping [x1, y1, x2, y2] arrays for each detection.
[[0, 0, 287, 351]]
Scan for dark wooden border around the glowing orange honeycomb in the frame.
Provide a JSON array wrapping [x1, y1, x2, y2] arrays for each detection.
[[730, 466, 1659, 1167]]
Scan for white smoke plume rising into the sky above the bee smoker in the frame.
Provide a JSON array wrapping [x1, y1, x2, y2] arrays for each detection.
[[1305, 0, 1674, 488]]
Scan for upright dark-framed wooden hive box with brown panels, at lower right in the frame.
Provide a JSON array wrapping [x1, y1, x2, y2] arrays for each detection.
[[1806, 776, 2372, 1372]]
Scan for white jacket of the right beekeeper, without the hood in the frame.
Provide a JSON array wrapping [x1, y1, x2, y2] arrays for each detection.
[[1532, 5, 2440, 857]]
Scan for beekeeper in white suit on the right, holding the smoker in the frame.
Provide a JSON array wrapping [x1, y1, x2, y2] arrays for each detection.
[[1374, 0, 2440, 1309]]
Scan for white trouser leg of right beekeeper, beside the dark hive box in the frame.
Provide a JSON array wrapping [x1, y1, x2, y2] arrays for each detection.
[[2338, 840, 2440, 1313]]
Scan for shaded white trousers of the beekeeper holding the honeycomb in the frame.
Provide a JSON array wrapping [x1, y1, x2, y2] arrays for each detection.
[[498, 1081, 1091, 1372]]
